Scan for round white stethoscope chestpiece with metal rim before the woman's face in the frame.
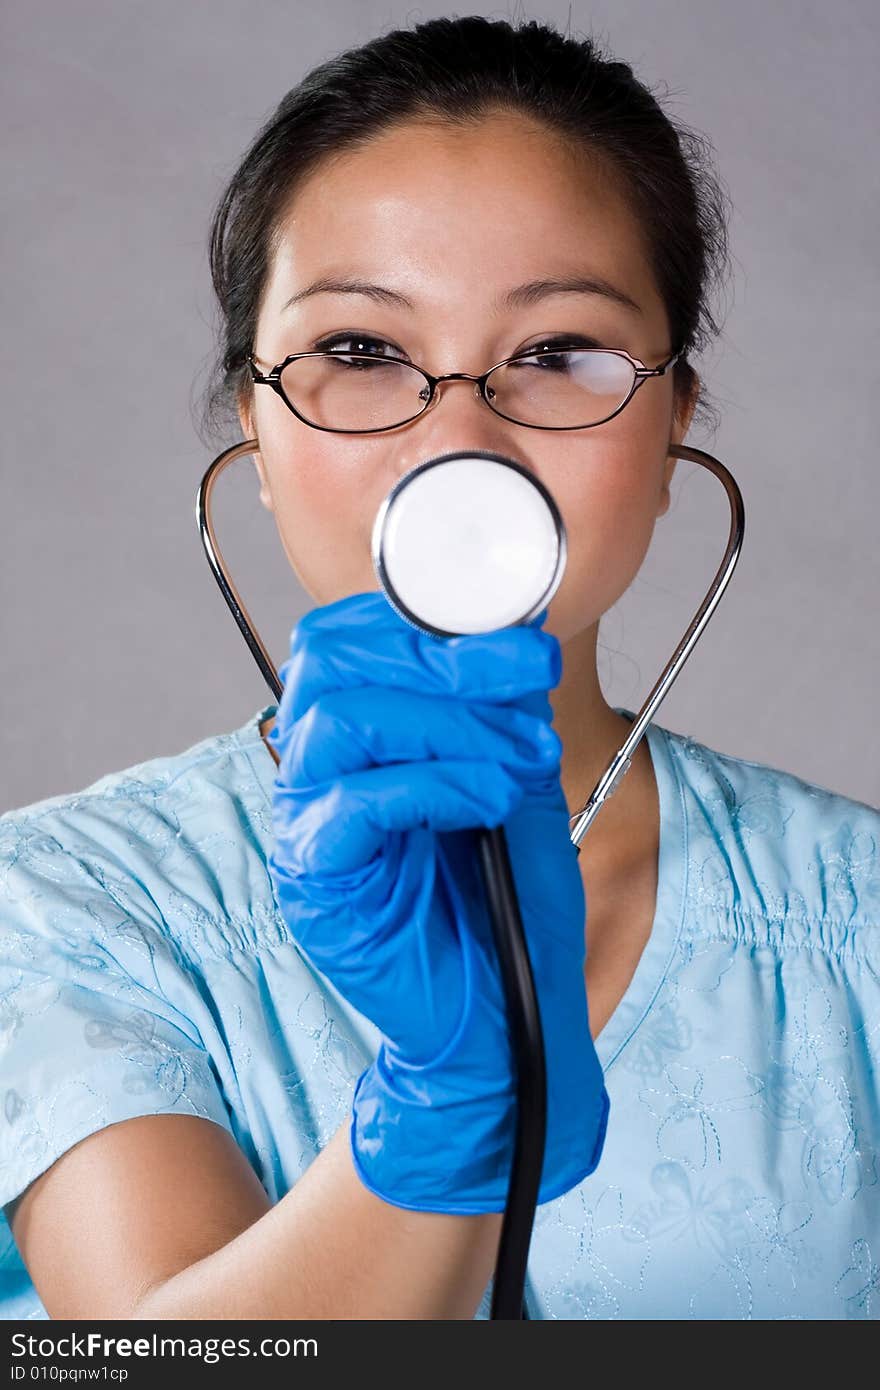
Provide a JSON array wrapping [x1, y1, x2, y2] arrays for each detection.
[[373, 449, 566, 637]]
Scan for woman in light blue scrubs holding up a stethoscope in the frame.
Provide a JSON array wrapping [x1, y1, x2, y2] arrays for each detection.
[[0, 17, 880, 1318]]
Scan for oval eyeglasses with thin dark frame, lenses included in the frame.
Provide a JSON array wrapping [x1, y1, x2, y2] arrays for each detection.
[[247, 335, 681, 434]]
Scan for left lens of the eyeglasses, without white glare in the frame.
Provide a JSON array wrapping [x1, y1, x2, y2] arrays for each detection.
[[281, 353, 428, 430]]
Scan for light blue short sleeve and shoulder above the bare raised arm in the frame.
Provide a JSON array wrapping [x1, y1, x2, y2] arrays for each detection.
[[0, 716, 274, 1234]]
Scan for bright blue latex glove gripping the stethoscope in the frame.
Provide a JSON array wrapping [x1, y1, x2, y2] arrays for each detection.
[[268, 591, 609, 1215]]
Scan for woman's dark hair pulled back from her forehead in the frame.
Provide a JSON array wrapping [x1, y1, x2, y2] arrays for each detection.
[[199, 15, 728, 442]]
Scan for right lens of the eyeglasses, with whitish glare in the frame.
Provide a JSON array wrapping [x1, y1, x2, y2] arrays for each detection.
[[487, 348, 635, 430]]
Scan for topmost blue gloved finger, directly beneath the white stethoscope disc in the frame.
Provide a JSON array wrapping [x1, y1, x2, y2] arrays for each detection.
[[277, 592, 562, 737]]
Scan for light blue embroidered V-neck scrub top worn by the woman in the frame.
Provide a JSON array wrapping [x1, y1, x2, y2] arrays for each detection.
[[0, 705, 880, 1319]]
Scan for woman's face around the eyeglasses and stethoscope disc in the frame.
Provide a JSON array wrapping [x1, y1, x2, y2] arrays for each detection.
[[239, 114, 691, 642]]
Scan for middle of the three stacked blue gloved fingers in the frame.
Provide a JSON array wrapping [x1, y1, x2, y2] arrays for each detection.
[[278, 685, 562, 790]]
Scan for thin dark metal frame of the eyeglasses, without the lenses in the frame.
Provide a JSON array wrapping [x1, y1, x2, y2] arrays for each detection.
[[246, 346, 683, 434]]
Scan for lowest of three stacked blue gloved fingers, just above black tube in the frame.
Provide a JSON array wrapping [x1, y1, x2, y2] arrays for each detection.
[[272, 759, 524, 872]]
